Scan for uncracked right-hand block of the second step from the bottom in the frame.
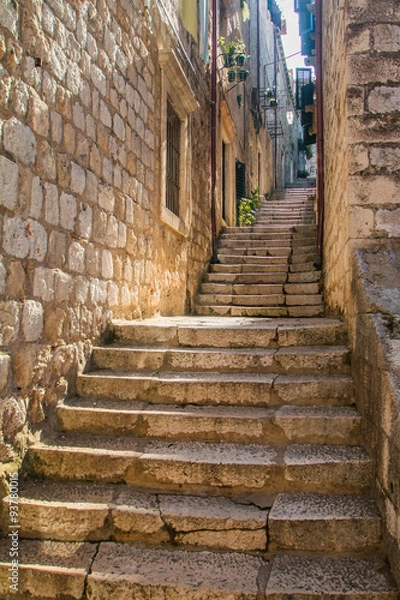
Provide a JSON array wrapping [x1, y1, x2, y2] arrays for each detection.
[[268, 494, 381, 553]]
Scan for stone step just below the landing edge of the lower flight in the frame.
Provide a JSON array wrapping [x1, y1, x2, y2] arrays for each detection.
[[92, 346, 350, 375]]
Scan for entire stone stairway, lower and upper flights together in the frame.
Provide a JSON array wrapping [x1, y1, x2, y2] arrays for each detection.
[[0, 192, 398, 600]]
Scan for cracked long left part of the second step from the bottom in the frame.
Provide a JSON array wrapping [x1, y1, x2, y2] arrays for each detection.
[[8, 481, 268, 551]]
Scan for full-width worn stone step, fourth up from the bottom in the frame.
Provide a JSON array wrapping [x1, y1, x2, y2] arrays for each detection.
[[56, 399, 362, 446]]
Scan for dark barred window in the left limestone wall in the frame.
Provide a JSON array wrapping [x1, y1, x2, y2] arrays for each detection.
[[166, 102, 181, 217]]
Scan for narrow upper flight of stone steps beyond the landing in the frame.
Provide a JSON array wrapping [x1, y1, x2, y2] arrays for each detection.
[[195, 189, 323, 317]]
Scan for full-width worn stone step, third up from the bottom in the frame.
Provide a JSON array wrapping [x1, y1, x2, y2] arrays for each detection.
[[28, 434, 373, 496]]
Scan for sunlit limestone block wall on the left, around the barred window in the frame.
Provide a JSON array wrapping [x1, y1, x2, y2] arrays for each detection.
[[0, 0, 210, 460]]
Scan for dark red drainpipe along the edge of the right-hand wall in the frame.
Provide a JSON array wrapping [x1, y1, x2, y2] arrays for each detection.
[[315, 0, 325, 267]]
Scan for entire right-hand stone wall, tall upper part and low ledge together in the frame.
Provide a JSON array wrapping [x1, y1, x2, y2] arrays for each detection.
[[323, 0, 400, 582]]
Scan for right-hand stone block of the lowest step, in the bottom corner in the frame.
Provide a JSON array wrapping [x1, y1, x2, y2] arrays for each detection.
[[264, 555, 398, 600]]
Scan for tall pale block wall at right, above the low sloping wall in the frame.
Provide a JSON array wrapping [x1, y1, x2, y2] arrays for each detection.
[[323, 0, 400, 317]]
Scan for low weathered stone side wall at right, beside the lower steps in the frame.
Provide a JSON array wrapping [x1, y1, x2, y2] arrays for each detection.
[[352, 240, 400, 584]]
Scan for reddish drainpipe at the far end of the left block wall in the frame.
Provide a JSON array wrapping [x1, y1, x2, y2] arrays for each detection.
[[210, 0, 218, 263]]
